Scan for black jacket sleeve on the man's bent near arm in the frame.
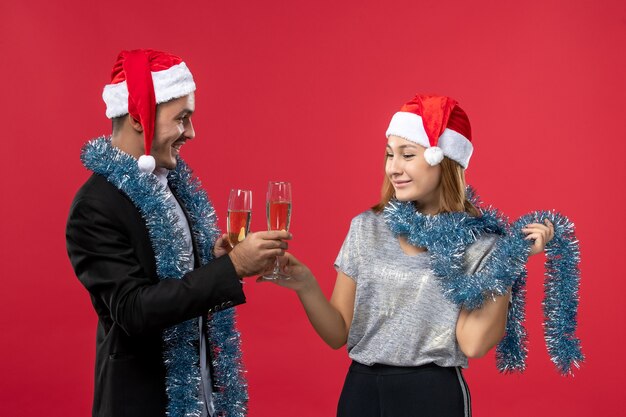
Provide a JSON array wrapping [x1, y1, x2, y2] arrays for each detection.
[[66, 194, 245, 335]]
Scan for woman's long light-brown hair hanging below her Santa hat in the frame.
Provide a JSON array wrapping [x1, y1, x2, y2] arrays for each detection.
[[372, 157, 480, 217]]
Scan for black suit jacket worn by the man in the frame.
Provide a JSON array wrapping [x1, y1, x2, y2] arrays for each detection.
[[66, 174, 245, 417]]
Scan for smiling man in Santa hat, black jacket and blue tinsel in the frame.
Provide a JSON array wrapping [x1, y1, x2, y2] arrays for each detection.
[[66, 50, 290, 417]]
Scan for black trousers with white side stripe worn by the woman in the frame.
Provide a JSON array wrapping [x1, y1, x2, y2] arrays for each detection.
[[337, 362, 472, 417]]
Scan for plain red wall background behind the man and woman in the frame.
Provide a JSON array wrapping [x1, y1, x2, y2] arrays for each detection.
[[0, 0, 626, 417]]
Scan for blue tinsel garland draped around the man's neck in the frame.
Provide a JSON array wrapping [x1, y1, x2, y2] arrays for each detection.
[[81, 137, 248, 417]]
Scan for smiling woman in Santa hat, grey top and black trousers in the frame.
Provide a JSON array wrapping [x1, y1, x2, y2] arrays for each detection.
[[260, 95, 554, 417]]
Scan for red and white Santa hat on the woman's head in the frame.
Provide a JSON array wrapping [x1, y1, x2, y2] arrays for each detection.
[[386, 94, 474, 168]]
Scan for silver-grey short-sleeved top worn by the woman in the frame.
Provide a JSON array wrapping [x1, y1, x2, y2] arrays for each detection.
[[335, 210, 498, 367]]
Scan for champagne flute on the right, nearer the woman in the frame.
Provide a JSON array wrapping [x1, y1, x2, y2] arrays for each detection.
[[263, 181, 291, 280]]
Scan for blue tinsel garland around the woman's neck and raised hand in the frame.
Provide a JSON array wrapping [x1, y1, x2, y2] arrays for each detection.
[[383, 187, 584, 375]]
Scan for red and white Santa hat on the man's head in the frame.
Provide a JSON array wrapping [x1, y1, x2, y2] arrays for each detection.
[[102, 49, 196, 172]]
